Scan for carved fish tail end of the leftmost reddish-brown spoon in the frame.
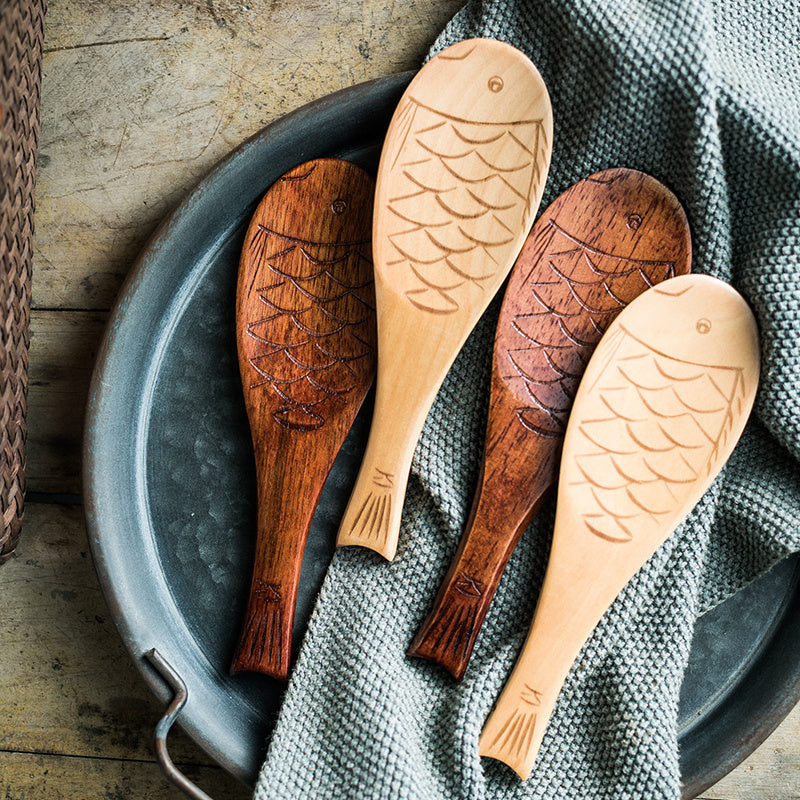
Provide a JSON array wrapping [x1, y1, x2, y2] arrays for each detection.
[[231, 593, 291, 680]]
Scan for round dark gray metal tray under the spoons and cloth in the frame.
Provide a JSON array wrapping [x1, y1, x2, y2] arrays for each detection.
[[84, 73, 800, 797]]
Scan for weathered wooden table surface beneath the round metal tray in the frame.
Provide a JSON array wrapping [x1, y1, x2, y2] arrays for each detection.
[[0, 0, 800, 800]]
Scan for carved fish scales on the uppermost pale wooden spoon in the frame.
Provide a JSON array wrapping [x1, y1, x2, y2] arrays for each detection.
[[382, 98, 548, 314]]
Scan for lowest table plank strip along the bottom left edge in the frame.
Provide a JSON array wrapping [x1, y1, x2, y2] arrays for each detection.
[[0, 752, 251, 800]]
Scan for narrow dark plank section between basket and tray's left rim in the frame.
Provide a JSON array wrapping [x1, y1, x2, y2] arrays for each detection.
[[26, 311, 106, 493]]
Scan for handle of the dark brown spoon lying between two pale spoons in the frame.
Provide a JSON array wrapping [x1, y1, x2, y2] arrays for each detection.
[[408, 378, 561, 680]]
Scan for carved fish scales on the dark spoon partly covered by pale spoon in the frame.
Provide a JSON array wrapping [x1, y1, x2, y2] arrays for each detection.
[[501, 220, 675, 438]]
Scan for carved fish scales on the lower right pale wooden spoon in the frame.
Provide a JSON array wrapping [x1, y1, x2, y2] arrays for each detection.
[[570, 326, 745, 543]]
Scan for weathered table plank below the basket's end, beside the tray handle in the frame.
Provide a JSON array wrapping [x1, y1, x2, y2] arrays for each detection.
[[0, 503, 238, 772]]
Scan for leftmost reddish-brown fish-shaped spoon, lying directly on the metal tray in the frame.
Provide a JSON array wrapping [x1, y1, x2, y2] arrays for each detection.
[[231, 159, 376, 678]]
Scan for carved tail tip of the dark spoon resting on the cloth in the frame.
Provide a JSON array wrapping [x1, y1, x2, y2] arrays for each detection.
[[408, 586, 488, 680]]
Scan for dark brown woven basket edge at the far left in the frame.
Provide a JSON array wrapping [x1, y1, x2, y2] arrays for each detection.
[[0, 0, 46, 564]]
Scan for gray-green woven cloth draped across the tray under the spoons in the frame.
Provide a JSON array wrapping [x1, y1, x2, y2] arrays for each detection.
[[255, 0, 800, 800]]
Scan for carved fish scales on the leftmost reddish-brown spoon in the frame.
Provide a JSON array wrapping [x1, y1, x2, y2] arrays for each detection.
[[246, 226, 375, 431]]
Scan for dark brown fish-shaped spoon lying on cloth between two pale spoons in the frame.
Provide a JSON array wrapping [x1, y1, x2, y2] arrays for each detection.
[[408, 169, 691, 679]]
